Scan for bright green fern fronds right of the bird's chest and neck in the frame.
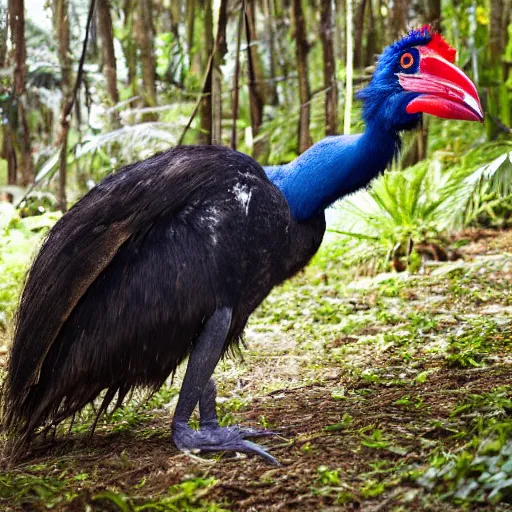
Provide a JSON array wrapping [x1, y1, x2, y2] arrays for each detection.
[[331, 138, 512, 270]]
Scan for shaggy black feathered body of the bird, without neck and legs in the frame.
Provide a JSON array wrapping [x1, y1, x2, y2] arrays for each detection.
[[4, 146, 325, 456]]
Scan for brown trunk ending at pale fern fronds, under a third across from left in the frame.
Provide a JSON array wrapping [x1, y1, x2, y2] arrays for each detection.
[[135, 0, 157, 116]]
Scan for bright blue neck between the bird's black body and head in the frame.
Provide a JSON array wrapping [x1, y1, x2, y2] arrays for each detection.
[[265, 125, 400, 221]]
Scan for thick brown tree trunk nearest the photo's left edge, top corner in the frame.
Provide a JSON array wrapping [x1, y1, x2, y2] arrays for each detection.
[[9, 0, 35, 186]]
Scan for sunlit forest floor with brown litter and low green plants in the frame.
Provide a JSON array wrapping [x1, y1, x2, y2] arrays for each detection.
[[0, 231, 512, 512]]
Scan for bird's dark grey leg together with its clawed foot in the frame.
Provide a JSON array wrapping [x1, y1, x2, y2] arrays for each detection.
[[172, 308, 278, 464]]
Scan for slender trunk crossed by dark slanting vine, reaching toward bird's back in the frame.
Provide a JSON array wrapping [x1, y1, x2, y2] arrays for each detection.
[[53, 0, 73, 212]]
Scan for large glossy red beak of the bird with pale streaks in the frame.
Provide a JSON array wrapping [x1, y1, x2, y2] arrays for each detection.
[[398, 46, 484, 121]]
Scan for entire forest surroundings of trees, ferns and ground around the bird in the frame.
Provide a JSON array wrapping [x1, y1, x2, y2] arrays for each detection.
[[0, 0, 512, 511]]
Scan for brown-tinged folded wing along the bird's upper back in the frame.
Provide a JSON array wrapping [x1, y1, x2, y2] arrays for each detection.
[[5, 147, 264, 410]]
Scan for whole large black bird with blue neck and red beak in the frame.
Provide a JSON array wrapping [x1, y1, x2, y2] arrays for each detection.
[[2, 26, 484, 464]]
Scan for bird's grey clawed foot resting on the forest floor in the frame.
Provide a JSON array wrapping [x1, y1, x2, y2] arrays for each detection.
[[172, 422, 280, 466]]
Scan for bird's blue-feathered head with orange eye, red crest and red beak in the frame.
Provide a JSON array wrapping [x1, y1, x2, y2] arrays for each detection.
[[358, 26, 484, 131]]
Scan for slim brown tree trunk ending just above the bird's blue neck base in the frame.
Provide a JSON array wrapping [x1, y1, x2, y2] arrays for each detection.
[[292, 0, 313, 153]]
